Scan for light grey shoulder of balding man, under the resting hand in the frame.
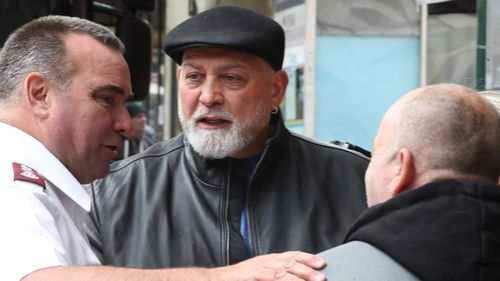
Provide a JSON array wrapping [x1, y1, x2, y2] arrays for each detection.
[[318, 241, 419, 281]]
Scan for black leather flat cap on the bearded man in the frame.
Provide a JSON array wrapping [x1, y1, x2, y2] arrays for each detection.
[[164, 6, 285, 70]]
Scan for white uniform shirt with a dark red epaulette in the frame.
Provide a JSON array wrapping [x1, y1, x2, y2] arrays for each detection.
[[0, 122, 99, 281]]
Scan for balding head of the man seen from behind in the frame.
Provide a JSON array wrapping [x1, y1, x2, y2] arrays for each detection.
[[366, 84, 500, 205]]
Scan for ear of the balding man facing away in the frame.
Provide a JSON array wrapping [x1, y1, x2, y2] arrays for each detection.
[[389, 148, 416, 197]]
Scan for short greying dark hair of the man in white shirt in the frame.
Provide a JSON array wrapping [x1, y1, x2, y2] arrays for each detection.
[[0, 16, 124, 103]]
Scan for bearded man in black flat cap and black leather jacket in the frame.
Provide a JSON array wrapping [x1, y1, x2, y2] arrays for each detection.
[[88, 6, 368, 268]]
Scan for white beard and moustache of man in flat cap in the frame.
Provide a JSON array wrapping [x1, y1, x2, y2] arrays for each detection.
[[178, 101, 269, 159]]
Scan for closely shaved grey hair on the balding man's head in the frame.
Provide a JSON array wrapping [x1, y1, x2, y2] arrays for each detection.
[[398, 84, 500, 179]]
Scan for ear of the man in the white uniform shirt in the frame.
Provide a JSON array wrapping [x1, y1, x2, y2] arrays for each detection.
[[23, 72, 50, 118]]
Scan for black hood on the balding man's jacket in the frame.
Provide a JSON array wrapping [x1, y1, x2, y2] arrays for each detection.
[[346, 180, 500, 280]]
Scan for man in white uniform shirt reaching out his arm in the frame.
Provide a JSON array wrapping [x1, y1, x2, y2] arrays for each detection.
[[0, 16, 325, 281]]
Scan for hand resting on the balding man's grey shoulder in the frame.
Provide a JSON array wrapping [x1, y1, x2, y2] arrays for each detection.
[[214, 251, 326, 281]]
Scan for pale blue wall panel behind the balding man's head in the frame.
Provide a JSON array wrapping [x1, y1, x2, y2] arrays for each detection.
[[315, 36, 419, 150]]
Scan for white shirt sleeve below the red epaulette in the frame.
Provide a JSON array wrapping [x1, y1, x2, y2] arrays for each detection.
[[0, 184, 68, 281]]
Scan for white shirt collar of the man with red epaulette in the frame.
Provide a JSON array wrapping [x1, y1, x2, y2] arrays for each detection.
[[0, 122, 90, 212]]
